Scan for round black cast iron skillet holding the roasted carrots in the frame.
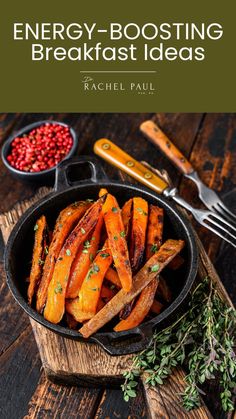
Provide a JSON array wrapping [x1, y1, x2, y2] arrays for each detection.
[[5, 156, 197, 355]]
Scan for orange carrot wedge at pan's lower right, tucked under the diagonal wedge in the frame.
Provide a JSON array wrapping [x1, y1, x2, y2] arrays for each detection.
[[114, 278, 158, 332]]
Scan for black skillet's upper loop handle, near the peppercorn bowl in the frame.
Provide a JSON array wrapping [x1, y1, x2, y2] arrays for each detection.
[[54, 156, 108, 192]]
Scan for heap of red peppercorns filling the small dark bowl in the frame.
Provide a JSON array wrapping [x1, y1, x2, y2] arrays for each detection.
[[7, 123, 73, 173]]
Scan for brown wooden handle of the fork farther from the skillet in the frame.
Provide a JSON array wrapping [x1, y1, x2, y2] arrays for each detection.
[[140, 121, 194, 175]]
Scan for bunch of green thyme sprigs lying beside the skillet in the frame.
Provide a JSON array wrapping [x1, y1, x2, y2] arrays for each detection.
[[121, 278, 236, 412]]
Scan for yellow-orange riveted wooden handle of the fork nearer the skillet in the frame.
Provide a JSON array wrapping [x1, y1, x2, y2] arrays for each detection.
[[93, 138, 168, 193]]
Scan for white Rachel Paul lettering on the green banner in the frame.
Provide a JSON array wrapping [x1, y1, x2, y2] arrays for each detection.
[[81, 76, 156, 95]]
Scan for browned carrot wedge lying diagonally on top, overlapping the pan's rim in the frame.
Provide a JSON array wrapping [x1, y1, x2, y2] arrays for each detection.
[[80, 240, 184, 338]]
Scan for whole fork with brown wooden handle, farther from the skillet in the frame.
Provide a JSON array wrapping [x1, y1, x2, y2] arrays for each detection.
[[140, 121, 236, 225]]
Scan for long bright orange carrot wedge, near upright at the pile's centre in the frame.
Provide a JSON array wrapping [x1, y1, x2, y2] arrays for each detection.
[[102, 194, 132, 292]]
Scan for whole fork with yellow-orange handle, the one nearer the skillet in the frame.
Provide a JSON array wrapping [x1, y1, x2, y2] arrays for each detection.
[[94, 138, 236, 247]]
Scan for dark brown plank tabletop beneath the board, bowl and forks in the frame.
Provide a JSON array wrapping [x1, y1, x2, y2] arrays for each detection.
[[0, 114, 236, 419]]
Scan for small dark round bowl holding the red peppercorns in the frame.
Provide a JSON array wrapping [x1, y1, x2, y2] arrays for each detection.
[[2, 120, 78, 184]]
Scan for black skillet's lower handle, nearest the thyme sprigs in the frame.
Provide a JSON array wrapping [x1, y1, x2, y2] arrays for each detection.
[[91, 325, 153, 356]]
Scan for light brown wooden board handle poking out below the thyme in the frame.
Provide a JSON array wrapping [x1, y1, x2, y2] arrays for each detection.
[[141, 368, 212, 419]]
